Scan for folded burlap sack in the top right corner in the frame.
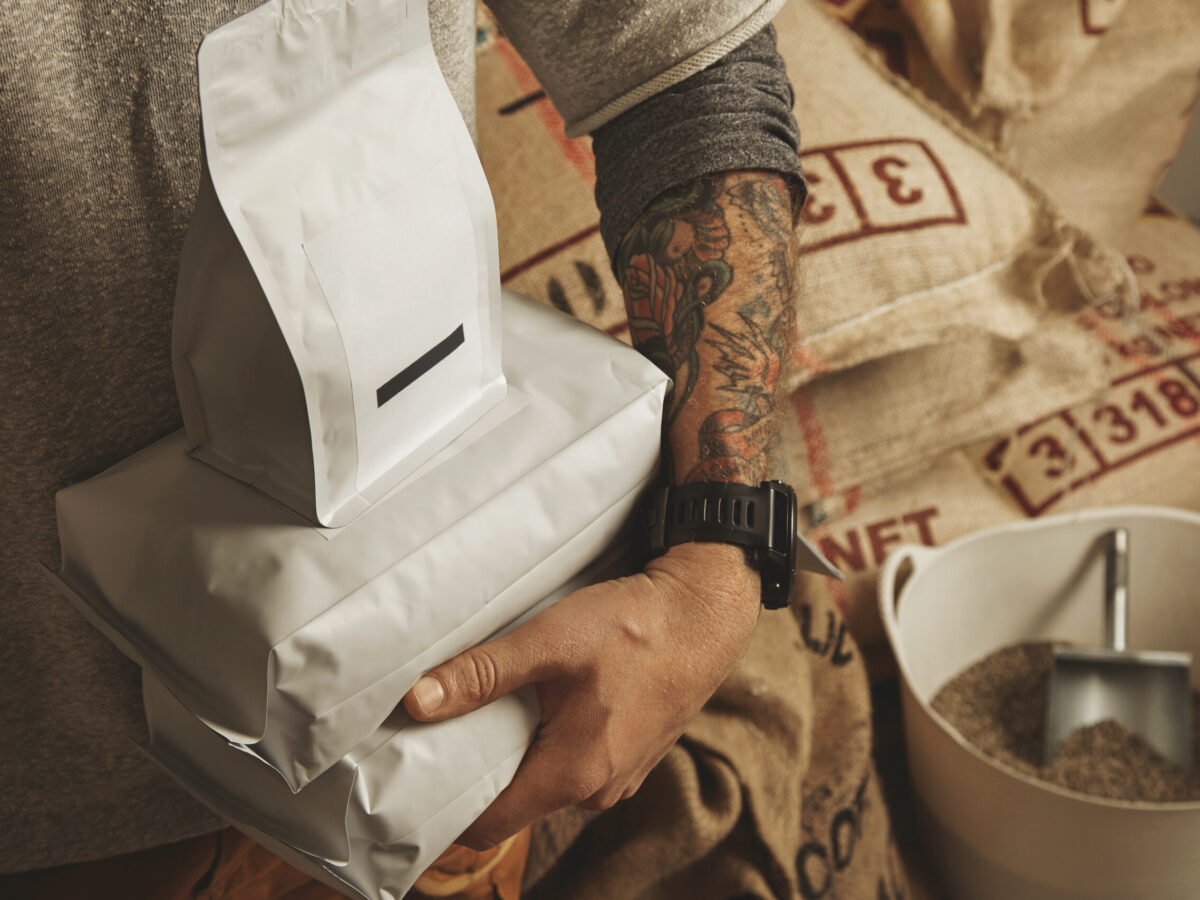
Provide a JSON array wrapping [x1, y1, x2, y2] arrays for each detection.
[[844, 0, 1200, 241]]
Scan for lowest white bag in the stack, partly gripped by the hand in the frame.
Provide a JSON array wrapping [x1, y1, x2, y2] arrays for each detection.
[[143, 561, 635, 900]]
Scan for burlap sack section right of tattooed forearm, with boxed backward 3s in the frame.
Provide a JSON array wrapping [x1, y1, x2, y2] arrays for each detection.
[[778, 2, 1132, 498]]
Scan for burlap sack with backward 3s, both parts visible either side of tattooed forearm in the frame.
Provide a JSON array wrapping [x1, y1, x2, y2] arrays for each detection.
[[479, 0, 1128, 508]]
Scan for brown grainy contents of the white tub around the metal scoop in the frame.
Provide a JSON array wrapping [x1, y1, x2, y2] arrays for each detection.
[[934, 642, 1200, 803]]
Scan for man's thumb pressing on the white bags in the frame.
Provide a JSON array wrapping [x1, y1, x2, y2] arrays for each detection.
[[403, 618, 553, 722]]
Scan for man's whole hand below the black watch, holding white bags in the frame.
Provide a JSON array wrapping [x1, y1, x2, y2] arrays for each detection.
[[404, 544, 760, 850]]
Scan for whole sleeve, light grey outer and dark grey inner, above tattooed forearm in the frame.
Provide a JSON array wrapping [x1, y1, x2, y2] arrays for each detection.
[[488, 0, 804, 267]]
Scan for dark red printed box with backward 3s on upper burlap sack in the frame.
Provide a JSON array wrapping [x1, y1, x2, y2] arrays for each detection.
[[800, 138, 967, 252]]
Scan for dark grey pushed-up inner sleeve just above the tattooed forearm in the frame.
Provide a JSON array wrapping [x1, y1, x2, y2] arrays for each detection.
[[592, 25, 805, 267]]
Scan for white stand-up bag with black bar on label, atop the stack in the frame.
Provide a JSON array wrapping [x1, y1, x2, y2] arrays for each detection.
[[173, 0, 505, 526]]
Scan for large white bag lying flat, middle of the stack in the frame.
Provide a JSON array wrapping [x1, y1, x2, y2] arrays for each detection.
[[58, 292, 667, 790]]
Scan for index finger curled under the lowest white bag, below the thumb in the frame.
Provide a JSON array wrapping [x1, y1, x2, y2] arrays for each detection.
[[455, 740, 600, 850]]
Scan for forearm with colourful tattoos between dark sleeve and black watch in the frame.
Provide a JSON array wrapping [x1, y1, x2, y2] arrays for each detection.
[[617, 172, 793, 484]]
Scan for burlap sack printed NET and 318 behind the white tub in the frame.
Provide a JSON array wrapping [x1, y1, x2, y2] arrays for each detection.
[[800, 212, 1200, 676]]
